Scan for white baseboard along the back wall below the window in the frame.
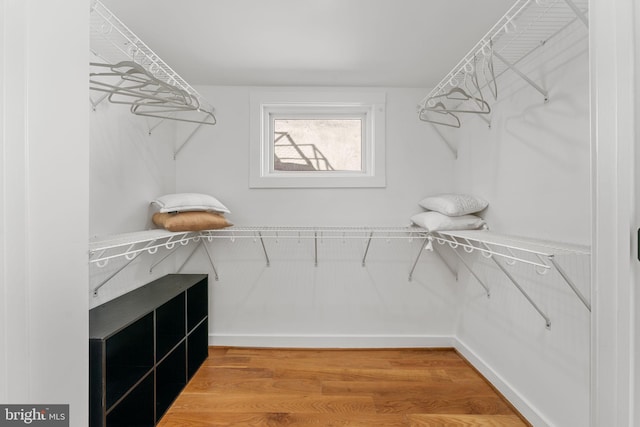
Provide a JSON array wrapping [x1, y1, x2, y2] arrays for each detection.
[[209, 334, 455, 348]]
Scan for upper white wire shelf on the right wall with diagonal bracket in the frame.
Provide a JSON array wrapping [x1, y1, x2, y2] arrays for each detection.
[[418, 0, 589, 117]]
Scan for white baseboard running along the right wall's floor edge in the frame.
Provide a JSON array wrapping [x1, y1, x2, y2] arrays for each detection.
[[453, 337, 552, 427]]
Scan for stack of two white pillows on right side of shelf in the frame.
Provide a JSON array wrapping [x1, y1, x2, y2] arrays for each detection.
[[411, 194, 489, 231]]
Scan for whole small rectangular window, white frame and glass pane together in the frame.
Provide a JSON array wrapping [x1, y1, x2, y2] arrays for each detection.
[[250, 92, 385, 188]]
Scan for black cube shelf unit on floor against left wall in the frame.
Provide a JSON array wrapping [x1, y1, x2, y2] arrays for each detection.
[[89, 274, 209, 427]]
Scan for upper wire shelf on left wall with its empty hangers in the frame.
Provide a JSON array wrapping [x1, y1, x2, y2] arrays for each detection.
[[90, 0, 216, 124]]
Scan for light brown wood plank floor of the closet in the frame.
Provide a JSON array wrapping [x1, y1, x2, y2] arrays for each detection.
[[159, 347, 530, 427]]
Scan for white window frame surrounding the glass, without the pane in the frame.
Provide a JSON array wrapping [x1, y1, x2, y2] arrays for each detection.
[[249, 91, 386, 188]]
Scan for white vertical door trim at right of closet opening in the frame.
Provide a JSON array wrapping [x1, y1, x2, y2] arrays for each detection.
[[589, 0, 637, 427]]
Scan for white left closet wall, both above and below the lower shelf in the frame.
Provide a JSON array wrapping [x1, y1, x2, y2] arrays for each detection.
[[87, 77, 176, 307]]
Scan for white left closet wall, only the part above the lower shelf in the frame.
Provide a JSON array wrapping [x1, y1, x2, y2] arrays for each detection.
[[89, 79, 176, 237]]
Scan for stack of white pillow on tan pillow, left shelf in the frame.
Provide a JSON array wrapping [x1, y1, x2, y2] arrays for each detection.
[[151, 193, 233, 231]]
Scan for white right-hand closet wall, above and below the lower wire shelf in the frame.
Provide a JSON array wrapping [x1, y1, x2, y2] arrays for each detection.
[[449, 22, 591, 426]]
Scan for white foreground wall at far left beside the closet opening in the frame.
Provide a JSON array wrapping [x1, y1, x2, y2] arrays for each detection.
[[0, 0, 89, 427]]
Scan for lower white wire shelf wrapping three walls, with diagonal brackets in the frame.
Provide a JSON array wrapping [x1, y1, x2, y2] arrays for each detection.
[[89, 226, 591, 328]]
